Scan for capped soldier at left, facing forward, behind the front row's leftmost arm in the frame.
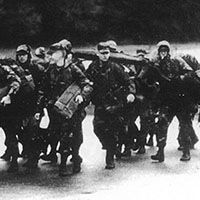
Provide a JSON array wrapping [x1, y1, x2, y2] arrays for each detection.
[[16, 44, 44, 168]]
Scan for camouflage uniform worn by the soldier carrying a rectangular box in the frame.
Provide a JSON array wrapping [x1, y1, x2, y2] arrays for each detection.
[[40, 53, 88, 175]]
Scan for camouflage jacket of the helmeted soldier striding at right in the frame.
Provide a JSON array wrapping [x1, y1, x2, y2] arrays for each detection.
[[149, 55, 195, 105]]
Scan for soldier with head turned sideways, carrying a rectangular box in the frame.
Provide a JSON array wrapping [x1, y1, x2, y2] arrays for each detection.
[[37, 43, 89, 176]]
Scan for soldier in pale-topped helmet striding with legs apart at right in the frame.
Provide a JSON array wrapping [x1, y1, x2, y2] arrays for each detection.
[[150, 41, 194, 162]]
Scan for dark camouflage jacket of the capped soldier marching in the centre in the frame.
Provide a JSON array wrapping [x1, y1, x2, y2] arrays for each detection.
[[86, 60, 136, 105]]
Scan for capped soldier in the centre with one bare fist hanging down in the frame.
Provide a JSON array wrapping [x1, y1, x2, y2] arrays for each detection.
[[86, 42, 136, 169]]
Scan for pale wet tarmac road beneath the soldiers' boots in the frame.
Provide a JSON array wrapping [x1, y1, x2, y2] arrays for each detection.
[[0, 116, 200, 200]]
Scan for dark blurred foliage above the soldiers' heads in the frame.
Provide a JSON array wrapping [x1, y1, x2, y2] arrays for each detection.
[[0, 0, 200, 46]]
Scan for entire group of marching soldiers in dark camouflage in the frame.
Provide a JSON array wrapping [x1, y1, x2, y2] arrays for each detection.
[[0, 39, 200, 176]]
